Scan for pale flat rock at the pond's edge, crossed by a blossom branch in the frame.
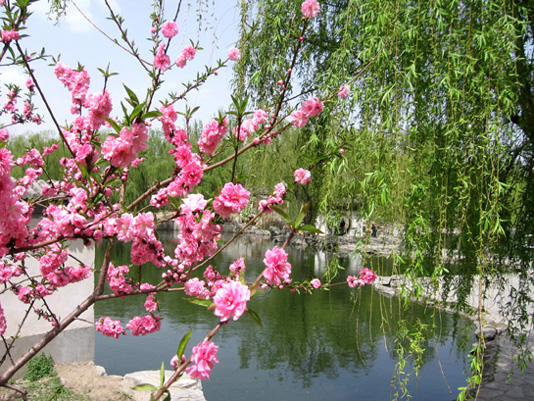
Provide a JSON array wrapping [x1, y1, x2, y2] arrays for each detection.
[[122, 370, 206, 401]]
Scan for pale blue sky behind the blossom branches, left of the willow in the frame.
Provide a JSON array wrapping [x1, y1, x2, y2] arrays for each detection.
[[0, 0, 240, 134]]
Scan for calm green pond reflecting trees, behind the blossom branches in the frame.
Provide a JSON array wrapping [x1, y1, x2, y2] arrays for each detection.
[[95, 233, 472, 401]]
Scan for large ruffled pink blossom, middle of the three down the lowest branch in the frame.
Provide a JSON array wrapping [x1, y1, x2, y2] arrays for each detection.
[[213, 281, 250, 322]]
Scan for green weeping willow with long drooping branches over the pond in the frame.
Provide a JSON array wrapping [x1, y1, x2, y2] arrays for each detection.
[[236, 0, 534, 392]]
